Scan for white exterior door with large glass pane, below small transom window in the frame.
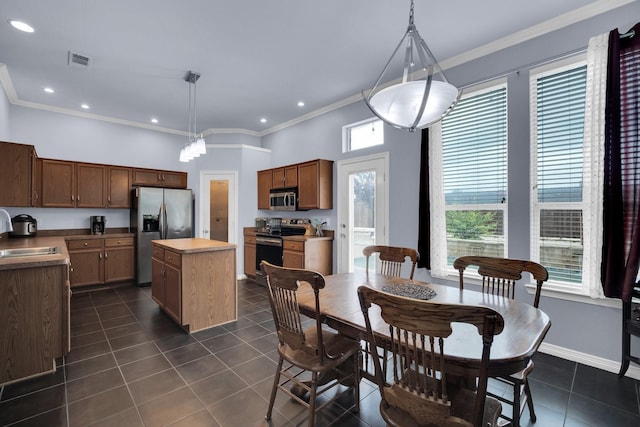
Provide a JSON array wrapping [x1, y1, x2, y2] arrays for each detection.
[[336, 153, 389, 273]]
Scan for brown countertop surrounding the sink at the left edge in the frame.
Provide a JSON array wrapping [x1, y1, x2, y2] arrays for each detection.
[[0, 237, 69, 270]]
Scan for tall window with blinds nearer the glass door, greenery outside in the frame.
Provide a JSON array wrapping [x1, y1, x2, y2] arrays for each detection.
[[442, 84, 507, 266]]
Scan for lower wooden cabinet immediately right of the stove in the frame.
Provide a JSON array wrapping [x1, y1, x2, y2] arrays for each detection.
[[282, 236, 333, 275]]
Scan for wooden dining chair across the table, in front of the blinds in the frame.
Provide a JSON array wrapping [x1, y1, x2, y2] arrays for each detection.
[[453, 256, 549, 427]]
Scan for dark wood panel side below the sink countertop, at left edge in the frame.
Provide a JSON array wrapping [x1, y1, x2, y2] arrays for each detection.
[[0, 264, 71, 385]]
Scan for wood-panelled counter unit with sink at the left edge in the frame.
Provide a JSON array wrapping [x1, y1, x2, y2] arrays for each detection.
[[0, 237, 71, 385]]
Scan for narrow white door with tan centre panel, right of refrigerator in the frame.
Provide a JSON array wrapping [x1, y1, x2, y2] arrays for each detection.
[[197, 171, 238, 244]]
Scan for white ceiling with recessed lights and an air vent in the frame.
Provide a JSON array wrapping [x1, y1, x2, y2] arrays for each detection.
[[0, 0, 631, 135]]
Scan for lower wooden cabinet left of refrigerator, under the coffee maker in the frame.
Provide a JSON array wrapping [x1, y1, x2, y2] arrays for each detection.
[[67, 237, 135, 287]]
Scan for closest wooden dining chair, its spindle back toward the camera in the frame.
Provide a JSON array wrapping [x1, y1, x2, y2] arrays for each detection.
[[358, 286, 504, 427]]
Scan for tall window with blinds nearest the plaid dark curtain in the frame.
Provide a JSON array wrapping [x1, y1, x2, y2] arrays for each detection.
[[531, 64, 589, 285]]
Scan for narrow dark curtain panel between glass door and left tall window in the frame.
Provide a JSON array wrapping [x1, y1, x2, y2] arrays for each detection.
[[418, 129, 431, 270]]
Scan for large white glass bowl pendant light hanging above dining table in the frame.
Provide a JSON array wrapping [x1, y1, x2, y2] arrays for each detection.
[[362, 0, 460, 132]]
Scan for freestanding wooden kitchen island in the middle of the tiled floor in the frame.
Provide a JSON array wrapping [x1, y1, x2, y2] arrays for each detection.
[[151, 238, 238, 333]]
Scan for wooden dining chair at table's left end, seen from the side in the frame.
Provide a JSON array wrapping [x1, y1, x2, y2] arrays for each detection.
[[261, 261, 360, 426]]
